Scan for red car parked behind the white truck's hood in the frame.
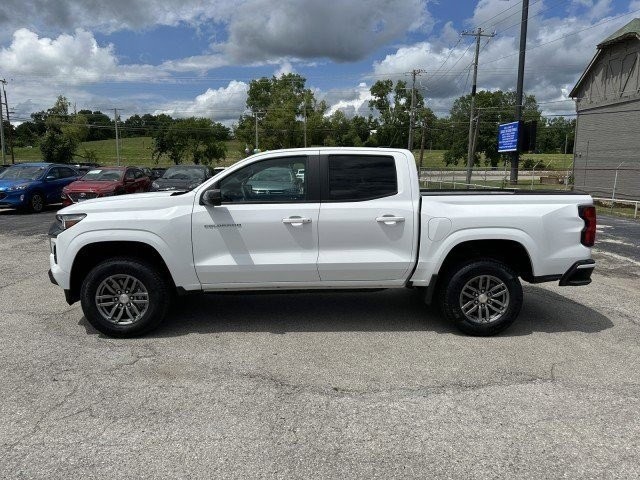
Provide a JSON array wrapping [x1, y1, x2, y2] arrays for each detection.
[[62, 167, 151, 207]]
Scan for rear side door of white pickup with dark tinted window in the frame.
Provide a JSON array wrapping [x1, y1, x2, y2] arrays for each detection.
[[318, 152, 416, 282]]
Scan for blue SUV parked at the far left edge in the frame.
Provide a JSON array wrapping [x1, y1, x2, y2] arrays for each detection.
[[0, 163, 80, 212]]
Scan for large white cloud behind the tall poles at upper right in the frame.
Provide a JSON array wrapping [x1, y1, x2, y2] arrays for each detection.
[[373, 0, 633, 114]]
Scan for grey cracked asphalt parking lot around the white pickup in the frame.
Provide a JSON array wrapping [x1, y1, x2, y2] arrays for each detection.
[[0, 210, 640, 479]]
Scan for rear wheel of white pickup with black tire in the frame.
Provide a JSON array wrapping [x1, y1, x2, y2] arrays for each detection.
[[438, 259, 522, 336]]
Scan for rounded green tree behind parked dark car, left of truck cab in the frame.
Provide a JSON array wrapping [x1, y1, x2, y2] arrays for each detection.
[[152, 117, 230, 165]]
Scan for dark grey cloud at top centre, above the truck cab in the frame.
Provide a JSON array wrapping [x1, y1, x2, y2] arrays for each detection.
[[220, 0, 432, 62]]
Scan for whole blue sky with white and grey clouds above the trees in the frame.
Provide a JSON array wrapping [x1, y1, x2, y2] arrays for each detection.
[[0, 0, 640, 124]]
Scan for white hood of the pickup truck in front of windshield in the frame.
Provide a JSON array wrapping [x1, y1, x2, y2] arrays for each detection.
[[58, 192, 193, 214]]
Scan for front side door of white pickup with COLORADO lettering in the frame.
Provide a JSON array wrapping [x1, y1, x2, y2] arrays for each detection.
[[192, 153, 320, 288]]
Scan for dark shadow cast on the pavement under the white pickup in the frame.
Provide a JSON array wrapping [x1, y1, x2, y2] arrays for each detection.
[[80, 287, 613, 337]]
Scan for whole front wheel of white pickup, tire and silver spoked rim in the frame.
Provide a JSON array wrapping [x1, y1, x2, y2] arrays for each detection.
[[80, 258, 172, 338]]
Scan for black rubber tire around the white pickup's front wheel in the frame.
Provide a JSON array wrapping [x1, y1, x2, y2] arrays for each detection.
[[80, 257, 173, 338]]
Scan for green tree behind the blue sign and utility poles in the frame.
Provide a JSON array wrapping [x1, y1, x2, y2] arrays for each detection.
[[444, 90, 541, 167]]
